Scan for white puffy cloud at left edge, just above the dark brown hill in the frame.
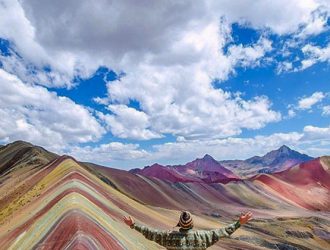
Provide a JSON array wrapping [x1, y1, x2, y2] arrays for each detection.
[[0, 69, 105, 151]]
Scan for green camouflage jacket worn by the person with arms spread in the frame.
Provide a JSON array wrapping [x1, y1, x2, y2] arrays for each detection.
[[131, 221, 240, 250]]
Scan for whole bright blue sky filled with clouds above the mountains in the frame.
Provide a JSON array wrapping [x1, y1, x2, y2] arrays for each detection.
[[0, 0, 330, 169]]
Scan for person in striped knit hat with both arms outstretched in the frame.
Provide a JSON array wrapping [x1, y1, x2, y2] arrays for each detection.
[[123, 211, 252, 250]]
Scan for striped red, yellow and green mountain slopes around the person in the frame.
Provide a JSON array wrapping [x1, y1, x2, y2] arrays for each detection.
[[0, 141, 330, 249]]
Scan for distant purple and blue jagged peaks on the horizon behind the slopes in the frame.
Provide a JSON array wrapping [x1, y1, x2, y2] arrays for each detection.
[[130, 146, 313, 183]]
